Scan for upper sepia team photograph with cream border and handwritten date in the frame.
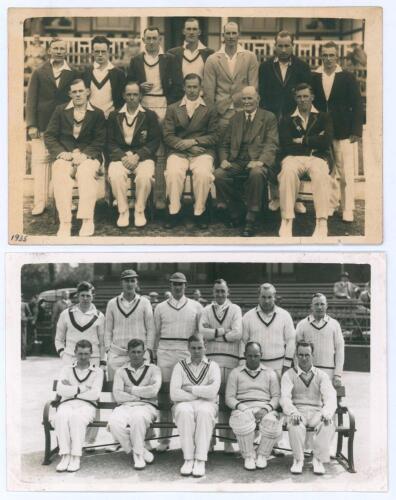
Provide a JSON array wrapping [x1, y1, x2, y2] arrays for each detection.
[[9, 8, 382, 244]]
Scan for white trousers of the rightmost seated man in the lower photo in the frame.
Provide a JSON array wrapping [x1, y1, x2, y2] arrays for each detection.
[[287, 407, 335, 463]]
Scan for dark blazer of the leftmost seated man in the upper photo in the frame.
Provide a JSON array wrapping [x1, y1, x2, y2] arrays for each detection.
[[44, 104, 106, 161]]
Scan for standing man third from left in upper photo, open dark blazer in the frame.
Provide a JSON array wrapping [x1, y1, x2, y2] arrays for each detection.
[[127, 27, 183, 122]]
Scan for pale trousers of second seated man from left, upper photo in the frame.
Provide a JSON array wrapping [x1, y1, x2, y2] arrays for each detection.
[[109, 160, 155, 213]]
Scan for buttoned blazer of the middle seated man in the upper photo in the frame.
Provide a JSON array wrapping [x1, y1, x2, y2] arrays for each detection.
[[162, 101, 219, 156]]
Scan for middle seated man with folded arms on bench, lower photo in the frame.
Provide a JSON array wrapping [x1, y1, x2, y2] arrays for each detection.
[[170, 334, 221, 477]]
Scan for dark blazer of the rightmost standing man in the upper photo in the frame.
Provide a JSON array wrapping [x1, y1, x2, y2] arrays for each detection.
[[312, 71, 363, 139]]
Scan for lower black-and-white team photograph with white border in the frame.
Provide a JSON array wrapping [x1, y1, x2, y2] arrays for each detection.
[[6, 253, 387, 491]]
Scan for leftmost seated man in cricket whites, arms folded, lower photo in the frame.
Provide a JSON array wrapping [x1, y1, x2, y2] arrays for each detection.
[[55, 340, 103, 472]]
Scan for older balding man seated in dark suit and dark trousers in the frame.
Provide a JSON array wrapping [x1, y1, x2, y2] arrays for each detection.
[[215, 87, 278, 236]]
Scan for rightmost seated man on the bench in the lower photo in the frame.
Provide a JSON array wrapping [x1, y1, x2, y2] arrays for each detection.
[[280, 342, 337, 474]]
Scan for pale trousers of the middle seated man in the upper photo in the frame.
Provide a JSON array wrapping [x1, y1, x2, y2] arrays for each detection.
[[165, 154, 214, 215]]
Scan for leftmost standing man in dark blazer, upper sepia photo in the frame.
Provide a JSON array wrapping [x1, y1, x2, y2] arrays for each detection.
[[26, 38, 77, 215]]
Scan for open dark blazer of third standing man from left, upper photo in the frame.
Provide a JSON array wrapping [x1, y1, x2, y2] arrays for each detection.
[[127, 53, 184, 105]]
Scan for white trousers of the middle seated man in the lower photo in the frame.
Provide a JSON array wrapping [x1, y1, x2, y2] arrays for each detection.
[[173, 399, 217, 462]]
